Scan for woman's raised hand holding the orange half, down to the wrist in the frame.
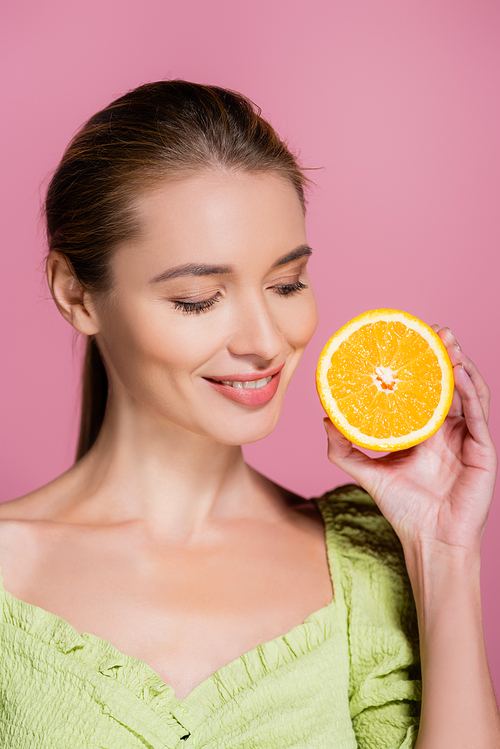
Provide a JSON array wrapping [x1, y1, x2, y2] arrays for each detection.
[[325, 325, 497, 551]]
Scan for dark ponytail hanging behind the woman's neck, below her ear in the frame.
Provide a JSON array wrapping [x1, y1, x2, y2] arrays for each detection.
[[76, 336, 108, 460]]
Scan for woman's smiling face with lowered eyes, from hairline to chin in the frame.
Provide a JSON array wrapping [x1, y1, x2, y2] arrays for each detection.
[[95, 171, 317, 444]]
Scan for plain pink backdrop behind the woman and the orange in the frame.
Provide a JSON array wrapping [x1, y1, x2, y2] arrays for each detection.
[[0, 0, 500, 691]]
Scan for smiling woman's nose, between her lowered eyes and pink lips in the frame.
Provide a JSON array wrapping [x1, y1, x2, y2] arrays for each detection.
[[228, 295, 284, 362]]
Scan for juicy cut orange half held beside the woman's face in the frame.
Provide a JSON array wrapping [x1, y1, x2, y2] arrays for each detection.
[[316, 309, 454, 451]]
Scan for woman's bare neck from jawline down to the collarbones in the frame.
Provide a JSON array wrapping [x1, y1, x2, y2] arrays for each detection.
[[59, 392, 279, 543]]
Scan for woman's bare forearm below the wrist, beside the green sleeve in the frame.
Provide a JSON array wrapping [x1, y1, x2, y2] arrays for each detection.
[[403, 543, 500, 749]]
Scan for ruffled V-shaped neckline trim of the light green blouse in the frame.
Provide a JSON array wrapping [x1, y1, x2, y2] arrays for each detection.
[[0, 495, 345, 731]]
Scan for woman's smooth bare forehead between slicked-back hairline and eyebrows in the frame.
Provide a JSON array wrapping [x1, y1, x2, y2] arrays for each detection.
[[127, 171, 305, 262]]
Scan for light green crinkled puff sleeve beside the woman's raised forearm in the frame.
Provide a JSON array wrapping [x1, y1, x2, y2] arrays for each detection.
[[324, 484, 422, 749]]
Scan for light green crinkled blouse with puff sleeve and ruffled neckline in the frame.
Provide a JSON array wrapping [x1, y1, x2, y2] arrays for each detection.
[[0, 484, 421, 749]]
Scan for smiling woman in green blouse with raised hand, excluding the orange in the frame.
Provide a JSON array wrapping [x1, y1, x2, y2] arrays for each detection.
[[0, 81, 500, 749]]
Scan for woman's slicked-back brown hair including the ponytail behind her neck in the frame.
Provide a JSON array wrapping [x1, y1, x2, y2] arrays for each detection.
[[45, 80, 309, 460]]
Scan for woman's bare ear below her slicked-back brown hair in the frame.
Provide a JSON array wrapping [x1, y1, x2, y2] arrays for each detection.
[[47, 250, 99, 335]]
